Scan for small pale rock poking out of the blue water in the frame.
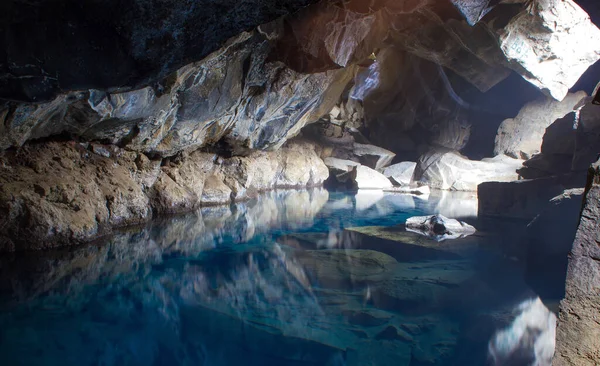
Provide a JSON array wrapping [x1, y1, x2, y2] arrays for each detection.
[[405, 215, 476, 241]]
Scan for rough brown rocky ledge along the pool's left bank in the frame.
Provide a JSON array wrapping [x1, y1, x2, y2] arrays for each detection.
[[0, 139, 329, 251]]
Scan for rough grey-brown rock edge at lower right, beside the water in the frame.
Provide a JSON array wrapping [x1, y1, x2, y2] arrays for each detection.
[[553, 161, 600, 366]]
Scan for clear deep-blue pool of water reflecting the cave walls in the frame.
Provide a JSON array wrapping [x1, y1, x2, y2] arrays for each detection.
[[0, 190, 555, 366]]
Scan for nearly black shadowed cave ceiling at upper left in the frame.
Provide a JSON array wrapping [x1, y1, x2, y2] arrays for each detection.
[[0, 0, 324, 102]]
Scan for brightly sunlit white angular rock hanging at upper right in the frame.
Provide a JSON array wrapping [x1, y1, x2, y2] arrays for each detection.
[[500, 0, 600, 100]]
